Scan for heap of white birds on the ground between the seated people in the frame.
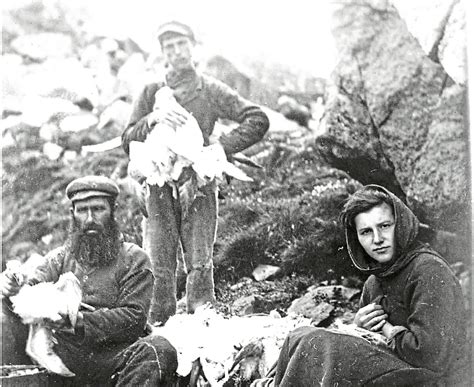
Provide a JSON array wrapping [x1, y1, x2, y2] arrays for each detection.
[[152, 305, 311, 387]]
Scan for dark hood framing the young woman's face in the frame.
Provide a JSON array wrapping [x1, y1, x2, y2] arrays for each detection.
[[345, 184, 419, 277]]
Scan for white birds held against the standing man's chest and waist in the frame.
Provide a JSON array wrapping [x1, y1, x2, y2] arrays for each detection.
[[128, 86, 252, 192]]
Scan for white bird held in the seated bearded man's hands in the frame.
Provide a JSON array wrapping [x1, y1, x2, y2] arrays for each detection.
[[10, 272, 82, 377]]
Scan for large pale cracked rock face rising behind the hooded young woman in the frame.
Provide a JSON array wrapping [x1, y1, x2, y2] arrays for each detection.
[[317, 0, 469, 260]]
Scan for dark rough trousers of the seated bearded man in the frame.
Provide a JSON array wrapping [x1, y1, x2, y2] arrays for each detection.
[[2, 300, 178, 386]]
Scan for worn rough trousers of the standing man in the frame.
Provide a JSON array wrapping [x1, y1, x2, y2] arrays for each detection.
[[143, 182, 218, 323]]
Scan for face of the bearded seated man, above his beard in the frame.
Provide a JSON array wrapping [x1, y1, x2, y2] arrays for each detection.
[[73, 197, 112, 236]]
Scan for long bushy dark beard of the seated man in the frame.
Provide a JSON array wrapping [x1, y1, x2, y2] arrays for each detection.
[[66, 216, 121, 267]]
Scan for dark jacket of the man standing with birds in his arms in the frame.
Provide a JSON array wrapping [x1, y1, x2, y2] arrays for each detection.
[[122, 71, 269, 155]]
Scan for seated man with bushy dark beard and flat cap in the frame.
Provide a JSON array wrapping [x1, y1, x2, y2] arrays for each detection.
[[0, 176, 177, 386]]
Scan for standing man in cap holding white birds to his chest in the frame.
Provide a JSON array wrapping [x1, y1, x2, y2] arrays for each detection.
[[122, 21, 269, 322]]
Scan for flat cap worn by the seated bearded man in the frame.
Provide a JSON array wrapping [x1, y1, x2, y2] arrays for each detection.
[[66, 175, 120, 202]]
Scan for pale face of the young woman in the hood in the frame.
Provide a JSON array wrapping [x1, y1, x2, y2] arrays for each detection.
[[354, 203, 396, 263]]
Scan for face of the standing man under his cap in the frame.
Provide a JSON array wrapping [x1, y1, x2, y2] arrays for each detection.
[[161, 35, 194, 71]]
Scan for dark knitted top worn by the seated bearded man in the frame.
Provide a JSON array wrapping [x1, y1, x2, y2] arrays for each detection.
[[29, 242, 153, 349]]
